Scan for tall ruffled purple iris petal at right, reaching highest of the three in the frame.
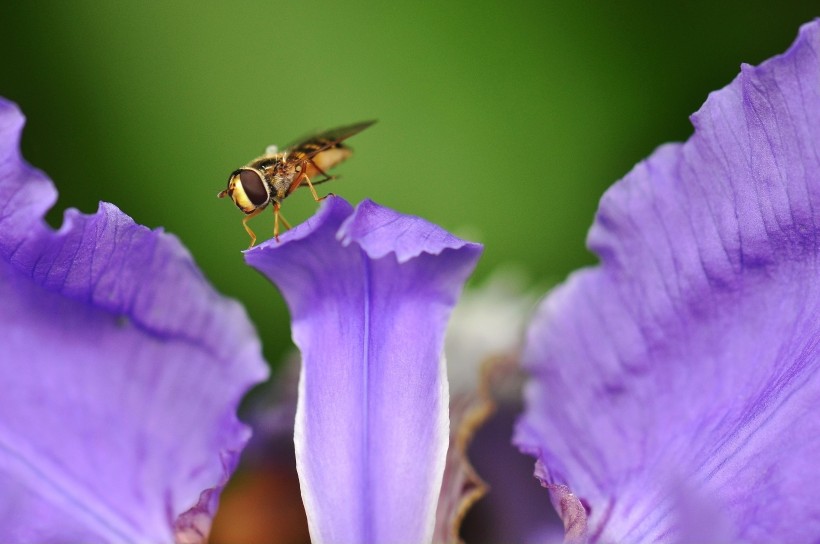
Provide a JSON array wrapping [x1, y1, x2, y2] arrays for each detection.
[[516, 21, 820, 543]]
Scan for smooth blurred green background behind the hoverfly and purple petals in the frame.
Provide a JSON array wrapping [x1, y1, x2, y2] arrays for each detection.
[[0, 0, 818, 541]]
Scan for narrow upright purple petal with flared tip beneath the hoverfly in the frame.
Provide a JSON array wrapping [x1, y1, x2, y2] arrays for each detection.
[[246, 197, 481, 543]]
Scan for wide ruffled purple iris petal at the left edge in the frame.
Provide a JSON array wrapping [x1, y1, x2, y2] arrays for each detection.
[[0, 95, 267, 542]]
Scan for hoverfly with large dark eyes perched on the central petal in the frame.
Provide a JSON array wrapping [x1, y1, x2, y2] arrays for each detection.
[[217, 121, 375, 247]]
